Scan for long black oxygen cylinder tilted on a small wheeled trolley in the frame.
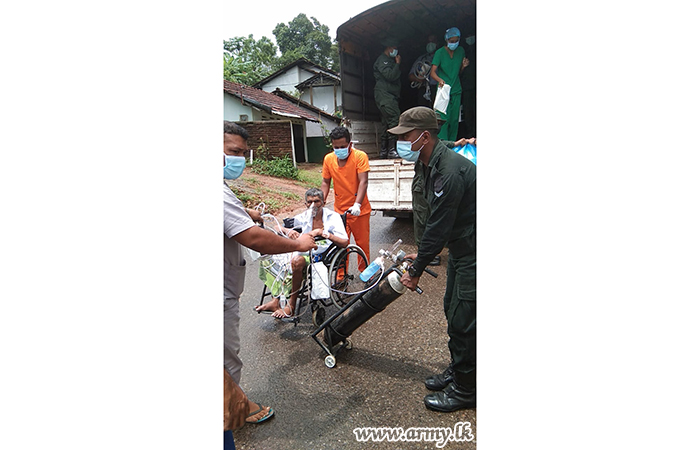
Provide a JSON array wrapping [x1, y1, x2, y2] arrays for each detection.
[[323, 271, 406, 348]]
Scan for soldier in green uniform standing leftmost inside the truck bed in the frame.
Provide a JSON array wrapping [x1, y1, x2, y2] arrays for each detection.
[[374, 38, 401, 159]]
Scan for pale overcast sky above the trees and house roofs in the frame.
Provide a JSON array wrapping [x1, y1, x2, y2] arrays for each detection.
[[223, 0, 385, 42]]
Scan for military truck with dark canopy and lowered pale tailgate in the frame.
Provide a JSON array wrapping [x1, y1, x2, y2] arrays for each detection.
[[336, 0, 476, 217]]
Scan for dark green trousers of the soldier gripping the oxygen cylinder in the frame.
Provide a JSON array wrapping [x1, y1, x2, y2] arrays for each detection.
[[444, 248, 476, 388]]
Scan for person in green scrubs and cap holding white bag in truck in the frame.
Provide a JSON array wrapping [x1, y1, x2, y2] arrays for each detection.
[[430, 27, 469, 141]]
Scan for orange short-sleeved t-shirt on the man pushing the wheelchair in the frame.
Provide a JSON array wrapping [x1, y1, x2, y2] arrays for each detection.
[[321, 147, 372, 216]]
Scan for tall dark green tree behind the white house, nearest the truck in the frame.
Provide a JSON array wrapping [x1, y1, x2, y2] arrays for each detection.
[[272, 14, 333, 68]]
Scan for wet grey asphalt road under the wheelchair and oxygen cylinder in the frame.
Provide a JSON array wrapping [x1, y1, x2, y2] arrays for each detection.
[[234, 213, 476, 450]]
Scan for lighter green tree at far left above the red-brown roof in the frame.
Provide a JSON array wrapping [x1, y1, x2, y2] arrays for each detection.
[[224, 34, 277, 85]]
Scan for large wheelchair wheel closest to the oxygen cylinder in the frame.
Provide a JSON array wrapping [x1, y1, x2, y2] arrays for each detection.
[[328, 244, 367, 308]]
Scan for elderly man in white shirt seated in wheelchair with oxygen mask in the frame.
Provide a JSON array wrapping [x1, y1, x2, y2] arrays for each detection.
[[255, 188, 350, 319]]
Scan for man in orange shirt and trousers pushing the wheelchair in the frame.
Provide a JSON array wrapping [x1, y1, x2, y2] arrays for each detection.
[[321, 127, 372, 271]]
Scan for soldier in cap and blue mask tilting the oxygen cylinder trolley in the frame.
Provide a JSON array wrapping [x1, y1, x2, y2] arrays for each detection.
[[389, 106, 476, 412]]
